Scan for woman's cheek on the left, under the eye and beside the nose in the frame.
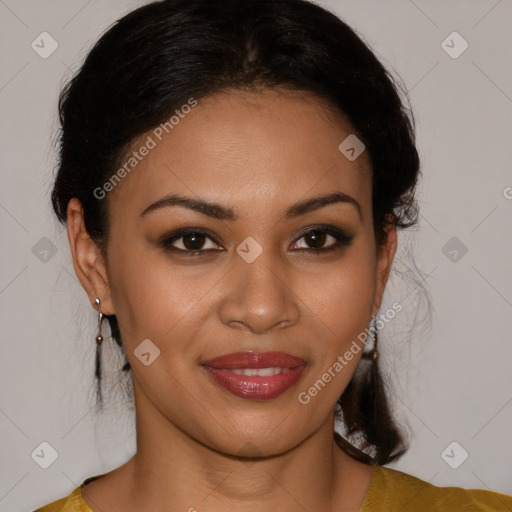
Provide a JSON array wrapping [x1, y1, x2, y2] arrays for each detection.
[[107, 248, 219, 359]]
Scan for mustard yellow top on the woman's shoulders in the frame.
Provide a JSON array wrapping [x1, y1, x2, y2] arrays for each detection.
[[34, 464, 512, 512]]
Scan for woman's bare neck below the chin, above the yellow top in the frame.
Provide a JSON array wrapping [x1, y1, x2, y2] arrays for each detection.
[[121, 378, 368, 512]]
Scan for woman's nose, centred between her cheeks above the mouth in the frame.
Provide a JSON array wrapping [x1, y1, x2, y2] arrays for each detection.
[[220, 251, 300, 334]]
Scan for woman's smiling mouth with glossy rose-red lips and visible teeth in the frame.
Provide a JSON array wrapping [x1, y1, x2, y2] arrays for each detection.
[[202, 352, 307, 400]]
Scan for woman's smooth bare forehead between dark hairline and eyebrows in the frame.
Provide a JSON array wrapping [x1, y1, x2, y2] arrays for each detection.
[[109, 89, 371, 222]]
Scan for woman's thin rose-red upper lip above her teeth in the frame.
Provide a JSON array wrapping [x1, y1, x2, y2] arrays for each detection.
[[202, 352, 306, 370]]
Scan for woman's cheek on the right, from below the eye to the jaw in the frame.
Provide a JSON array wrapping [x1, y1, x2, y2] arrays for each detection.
[[299, 244, 375, 396]]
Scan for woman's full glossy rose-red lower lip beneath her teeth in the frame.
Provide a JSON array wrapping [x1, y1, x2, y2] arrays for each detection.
[[203, 364, 306, 400]]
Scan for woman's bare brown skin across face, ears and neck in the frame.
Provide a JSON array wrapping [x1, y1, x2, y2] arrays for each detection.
[[68, 88, 397, 512]]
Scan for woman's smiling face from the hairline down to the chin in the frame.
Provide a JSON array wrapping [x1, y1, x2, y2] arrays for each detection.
[[78, 89, 396, 456]]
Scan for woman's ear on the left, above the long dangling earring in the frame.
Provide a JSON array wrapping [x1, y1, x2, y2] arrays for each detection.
[[67, 197, 115, 315]]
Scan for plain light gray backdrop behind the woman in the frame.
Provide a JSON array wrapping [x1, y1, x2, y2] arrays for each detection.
[[0, 0, 512, 512]]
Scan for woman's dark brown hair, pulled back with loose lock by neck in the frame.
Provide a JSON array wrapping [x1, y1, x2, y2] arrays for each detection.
[[51, 0, 420, 464]]
